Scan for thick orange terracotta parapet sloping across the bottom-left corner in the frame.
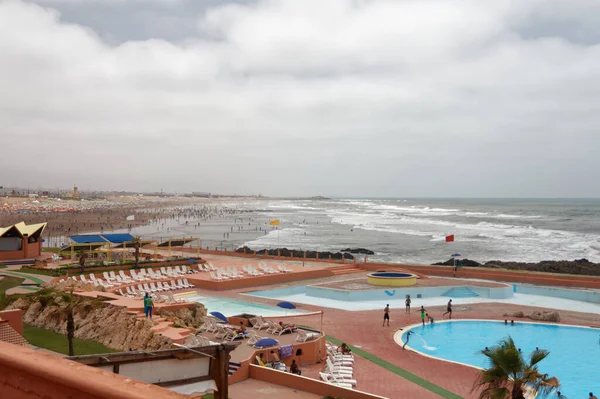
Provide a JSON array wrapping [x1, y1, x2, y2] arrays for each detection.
[[0, 342, 188, 399]]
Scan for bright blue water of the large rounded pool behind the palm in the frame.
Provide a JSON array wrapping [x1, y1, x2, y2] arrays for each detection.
[[402, 320, 600, 399]]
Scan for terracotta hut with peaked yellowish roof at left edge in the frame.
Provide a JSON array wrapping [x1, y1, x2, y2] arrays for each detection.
[[0, 222, 46, 261]]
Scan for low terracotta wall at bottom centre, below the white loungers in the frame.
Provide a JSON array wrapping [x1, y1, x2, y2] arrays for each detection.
[[250, 364, 383, 399]]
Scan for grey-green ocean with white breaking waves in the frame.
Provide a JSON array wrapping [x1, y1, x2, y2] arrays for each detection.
[[84, 198, 600, 264]]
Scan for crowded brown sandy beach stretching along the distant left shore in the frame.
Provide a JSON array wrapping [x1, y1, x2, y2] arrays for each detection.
[[0, 196, 268, 246]]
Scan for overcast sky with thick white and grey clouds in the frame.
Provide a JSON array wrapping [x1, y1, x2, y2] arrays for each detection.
[[0, 0, 600, 197]]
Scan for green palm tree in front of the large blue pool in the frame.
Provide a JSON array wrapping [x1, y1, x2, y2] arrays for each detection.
[[473, 336, 560, 399]]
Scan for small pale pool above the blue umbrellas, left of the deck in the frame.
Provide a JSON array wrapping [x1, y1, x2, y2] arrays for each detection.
[[185, 295, 306, 317]]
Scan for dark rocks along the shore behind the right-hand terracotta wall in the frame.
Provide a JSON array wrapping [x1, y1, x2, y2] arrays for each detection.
[[433, 258, 600, 276]]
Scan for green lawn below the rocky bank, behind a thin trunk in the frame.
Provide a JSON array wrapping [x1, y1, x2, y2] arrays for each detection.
[[23, 324, 117, 355]]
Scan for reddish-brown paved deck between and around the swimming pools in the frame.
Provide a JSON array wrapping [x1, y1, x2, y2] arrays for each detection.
[[184, 266, 600, 399]]
